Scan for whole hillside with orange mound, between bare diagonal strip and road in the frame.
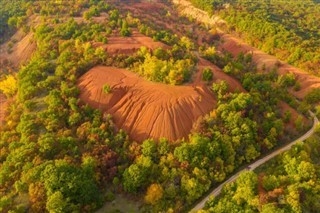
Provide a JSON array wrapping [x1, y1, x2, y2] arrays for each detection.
[[0, 0, 320, 213]]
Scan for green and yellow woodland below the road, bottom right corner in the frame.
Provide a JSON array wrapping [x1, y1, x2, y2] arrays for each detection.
[[202, 127, 320, 213]]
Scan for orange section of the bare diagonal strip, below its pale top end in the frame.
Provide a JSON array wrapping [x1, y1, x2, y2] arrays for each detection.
[[218, 33, 320, 99]]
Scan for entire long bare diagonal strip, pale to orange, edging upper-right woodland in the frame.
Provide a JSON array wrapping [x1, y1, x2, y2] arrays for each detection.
[[173, 0, 320, 99]]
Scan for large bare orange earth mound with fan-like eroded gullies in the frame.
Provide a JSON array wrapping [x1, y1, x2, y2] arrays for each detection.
[[78, 66, 216, 141]]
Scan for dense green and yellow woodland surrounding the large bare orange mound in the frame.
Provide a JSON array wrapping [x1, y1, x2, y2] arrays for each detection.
[[0, 0, 320, 212]]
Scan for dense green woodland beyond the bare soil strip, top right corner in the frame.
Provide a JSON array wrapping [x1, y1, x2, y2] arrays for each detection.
[[190, 0, 320, 75]]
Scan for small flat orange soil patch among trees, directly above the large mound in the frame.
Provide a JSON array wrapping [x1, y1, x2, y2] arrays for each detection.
[[94, 31, 168, 55]]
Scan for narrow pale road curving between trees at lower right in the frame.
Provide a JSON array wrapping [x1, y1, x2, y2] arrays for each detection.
[[190, 112, 319, 212]]
